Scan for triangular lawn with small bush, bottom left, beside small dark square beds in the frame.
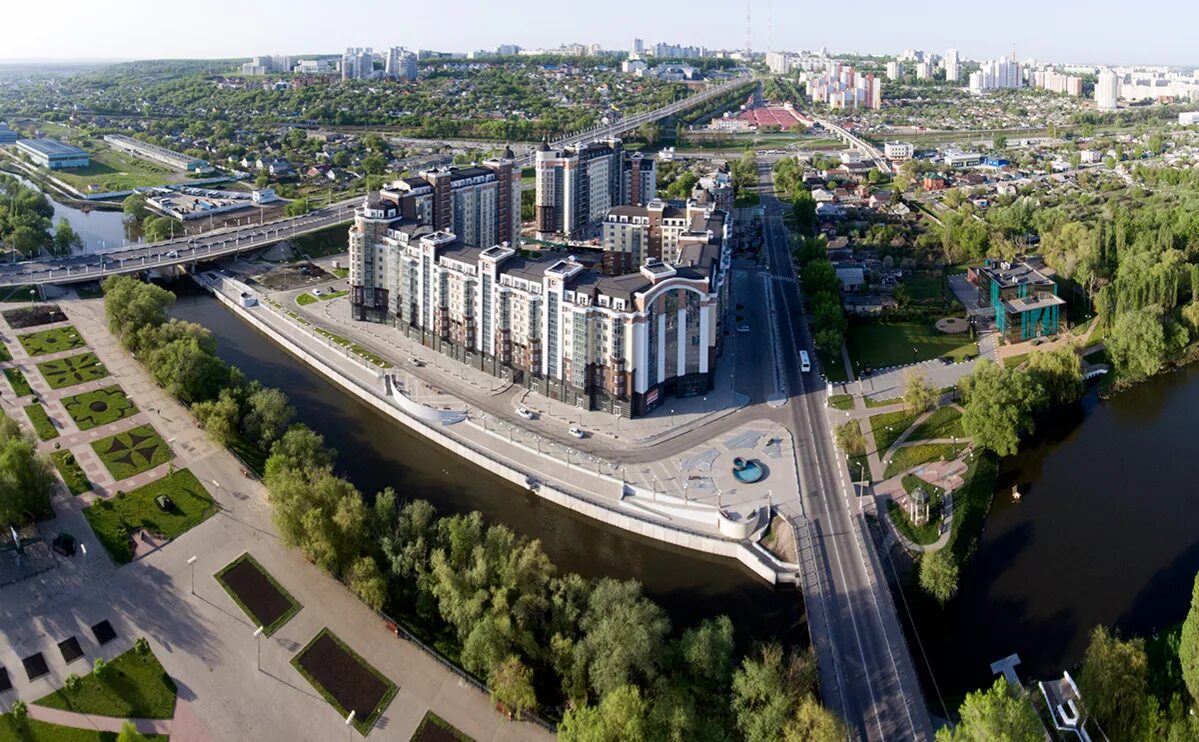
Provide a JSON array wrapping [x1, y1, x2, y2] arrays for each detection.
[[35, 649, 176, 719]]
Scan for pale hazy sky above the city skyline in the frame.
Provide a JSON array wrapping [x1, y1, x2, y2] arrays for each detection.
[[0, 0, 1199, 66]]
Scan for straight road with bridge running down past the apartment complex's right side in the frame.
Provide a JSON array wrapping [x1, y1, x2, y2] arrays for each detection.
[[759, 162, 933, 740]]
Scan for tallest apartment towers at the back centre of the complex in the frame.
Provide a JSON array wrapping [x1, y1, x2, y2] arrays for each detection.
[[534, 139, 657, 239]]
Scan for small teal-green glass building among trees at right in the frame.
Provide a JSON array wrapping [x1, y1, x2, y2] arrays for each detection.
[[966, 257, 1066, 343]]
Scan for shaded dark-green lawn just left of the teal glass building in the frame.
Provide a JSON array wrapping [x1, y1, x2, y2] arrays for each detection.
[[845, 320, 977, 370]]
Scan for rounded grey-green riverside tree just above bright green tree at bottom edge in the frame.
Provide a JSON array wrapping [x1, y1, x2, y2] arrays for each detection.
[[578, 578, 670, 696]]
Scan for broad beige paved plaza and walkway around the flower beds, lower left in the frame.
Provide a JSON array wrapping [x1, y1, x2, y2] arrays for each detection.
[[0, 300, 550, 742]]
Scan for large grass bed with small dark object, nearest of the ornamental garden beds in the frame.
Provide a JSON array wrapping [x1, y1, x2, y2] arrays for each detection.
[[83, 469, 217, 565]]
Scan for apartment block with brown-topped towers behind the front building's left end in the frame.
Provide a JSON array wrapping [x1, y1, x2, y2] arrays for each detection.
[[379, 150, 520, 247]]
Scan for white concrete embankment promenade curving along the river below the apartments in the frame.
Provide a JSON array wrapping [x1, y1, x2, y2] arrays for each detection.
[[197, 273, 797, 584]]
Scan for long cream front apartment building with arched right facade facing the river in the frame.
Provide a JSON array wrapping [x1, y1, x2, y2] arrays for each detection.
[[350, 198, 731, 416]]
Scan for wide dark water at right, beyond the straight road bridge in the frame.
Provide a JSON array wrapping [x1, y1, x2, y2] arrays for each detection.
[[900, 366, 1199, 710]]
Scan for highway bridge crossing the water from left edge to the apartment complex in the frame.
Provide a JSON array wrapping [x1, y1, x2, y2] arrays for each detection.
[[0, 197, 362, 285]]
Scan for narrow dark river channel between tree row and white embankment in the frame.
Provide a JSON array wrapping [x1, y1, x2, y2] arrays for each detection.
[[169, 280, 808, 646]]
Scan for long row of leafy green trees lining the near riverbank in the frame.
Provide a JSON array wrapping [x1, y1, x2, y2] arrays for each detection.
[[104, 277, 844, 742]]
